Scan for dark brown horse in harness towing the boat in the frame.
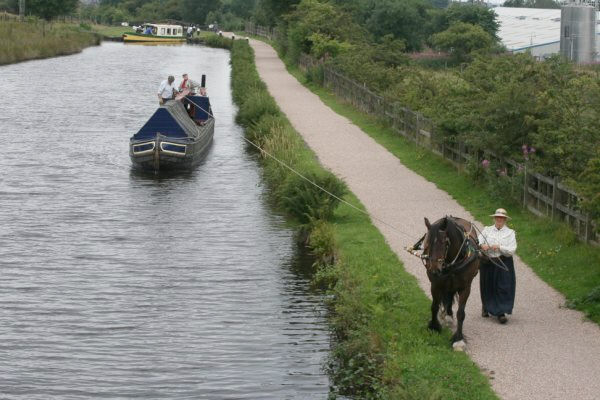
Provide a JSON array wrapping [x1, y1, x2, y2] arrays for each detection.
[[417, 216, 479, 349]]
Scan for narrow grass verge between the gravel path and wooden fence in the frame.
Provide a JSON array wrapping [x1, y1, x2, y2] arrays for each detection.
[[278, 50, 600, 323]]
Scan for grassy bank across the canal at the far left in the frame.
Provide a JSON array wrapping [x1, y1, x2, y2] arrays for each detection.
[[0, 20, 100, 65]]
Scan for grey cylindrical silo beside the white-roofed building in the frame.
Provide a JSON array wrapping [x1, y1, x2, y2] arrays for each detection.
[[560, 3, 596, 64]]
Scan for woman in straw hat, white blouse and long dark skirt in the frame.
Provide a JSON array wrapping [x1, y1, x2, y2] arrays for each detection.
[[479, 208, 517, 324]]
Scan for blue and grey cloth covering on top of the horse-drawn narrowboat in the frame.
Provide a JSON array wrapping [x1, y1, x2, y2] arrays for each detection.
[[133, 96, 210, 140]]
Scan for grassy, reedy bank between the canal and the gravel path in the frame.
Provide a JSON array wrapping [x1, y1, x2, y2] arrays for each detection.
[[223, 36, 496, 399]]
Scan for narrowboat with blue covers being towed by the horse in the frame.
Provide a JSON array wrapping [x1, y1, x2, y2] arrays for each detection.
[[129, 95, 215, 172]]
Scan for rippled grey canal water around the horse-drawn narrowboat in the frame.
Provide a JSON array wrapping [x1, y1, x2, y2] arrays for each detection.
[[0, 43, 329, 399]]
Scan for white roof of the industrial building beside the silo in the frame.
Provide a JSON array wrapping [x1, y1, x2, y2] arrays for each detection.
[[494, 7, 560, 50]]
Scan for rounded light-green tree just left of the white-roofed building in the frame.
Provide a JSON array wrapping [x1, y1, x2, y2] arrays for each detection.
[[431, 22, 494, 61]]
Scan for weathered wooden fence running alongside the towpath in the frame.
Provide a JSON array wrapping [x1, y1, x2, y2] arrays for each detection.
[[248, 27, 600, 246]]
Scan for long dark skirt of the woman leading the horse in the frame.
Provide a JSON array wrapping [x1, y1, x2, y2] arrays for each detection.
[[479, 256, 517, 316]]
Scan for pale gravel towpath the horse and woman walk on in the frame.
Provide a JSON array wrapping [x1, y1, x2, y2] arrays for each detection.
[[241, 40, 600, 400]]
